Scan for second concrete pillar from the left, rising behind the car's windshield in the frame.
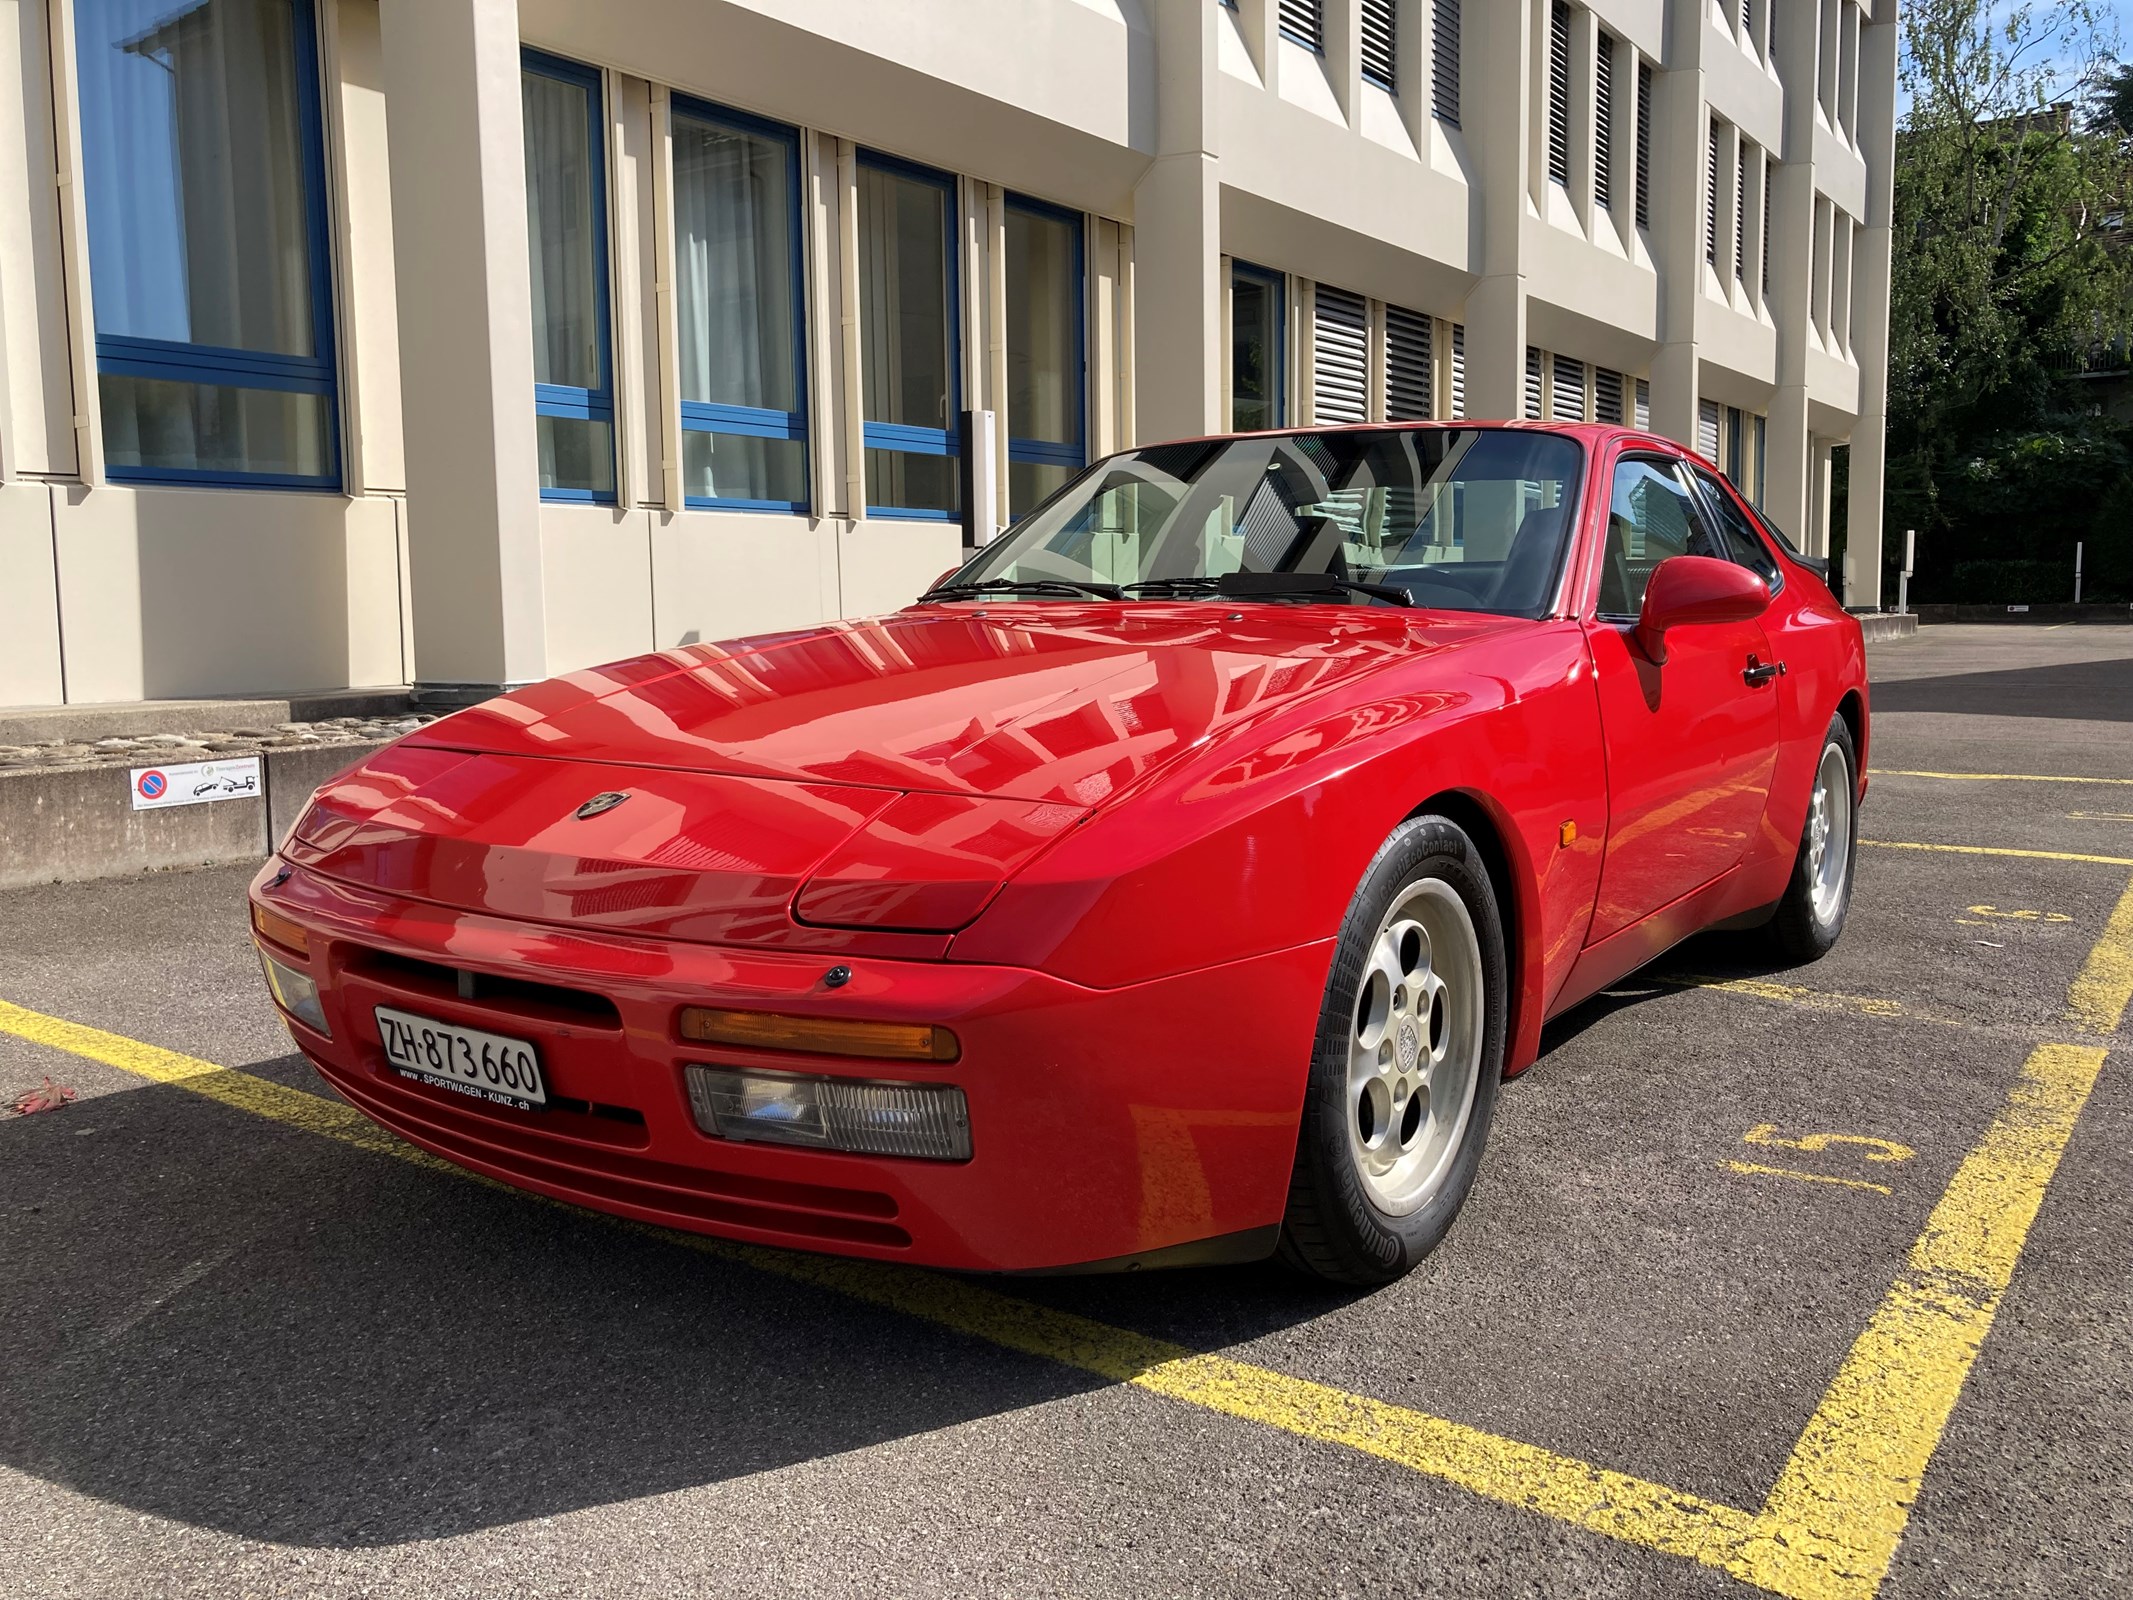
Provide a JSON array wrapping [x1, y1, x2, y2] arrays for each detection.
[[1133, 0, 1229, 444]]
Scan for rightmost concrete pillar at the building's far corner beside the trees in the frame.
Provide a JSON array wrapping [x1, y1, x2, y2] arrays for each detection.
[[1845, 4, 1896, 610]]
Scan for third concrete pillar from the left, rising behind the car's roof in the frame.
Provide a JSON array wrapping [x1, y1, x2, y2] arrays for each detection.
[[1459, 0, 1546, 420]]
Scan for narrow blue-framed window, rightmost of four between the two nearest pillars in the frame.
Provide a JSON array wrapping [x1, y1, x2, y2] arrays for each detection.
[[1007, 196, 1088, 516]]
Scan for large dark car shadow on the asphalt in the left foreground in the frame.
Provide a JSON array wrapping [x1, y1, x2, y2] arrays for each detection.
[[0, 1062, 1346, 1549]]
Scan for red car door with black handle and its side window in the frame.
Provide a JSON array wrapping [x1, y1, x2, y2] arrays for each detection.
[[1587, 454, 1779, 943]]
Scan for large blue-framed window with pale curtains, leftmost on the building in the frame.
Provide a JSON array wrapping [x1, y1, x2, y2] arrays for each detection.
[[75, 0, 339, 489]]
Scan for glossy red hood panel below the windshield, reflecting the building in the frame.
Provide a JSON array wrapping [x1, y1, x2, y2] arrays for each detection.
[[412, 604, 1512, 806]]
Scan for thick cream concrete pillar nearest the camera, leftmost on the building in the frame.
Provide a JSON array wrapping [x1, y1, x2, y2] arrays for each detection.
[[380, 0, 548, 702]]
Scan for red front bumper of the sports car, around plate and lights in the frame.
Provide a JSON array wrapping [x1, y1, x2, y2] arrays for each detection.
[[252, 862, 1331, 1271]]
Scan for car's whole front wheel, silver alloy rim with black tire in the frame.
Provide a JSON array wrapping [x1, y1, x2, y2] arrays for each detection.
[[1282, 817, 1508, 1284]]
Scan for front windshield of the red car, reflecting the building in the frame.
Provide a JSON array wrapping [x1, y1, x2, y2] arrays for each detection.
[[936, 429, 1583, 617]]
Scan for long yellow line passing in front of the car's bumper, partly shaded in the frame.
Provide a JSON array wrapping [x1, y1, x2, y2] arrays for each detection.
[[0, 1001, 1751, 1566]]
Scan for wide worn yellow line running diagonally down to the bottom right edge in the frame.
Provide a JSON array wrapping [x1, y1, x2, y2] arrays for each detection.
[[1728, 1045, 2103, 1600]]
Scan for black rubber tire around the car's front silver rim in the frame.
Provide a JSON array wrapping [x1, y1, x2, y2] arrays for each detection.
[[1280, 817, 1510, 1286]]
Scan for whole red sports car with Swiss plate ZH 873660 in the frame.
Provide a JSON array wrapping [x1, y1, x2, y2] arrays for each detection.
[[252, 422, 1866, 1282]]
